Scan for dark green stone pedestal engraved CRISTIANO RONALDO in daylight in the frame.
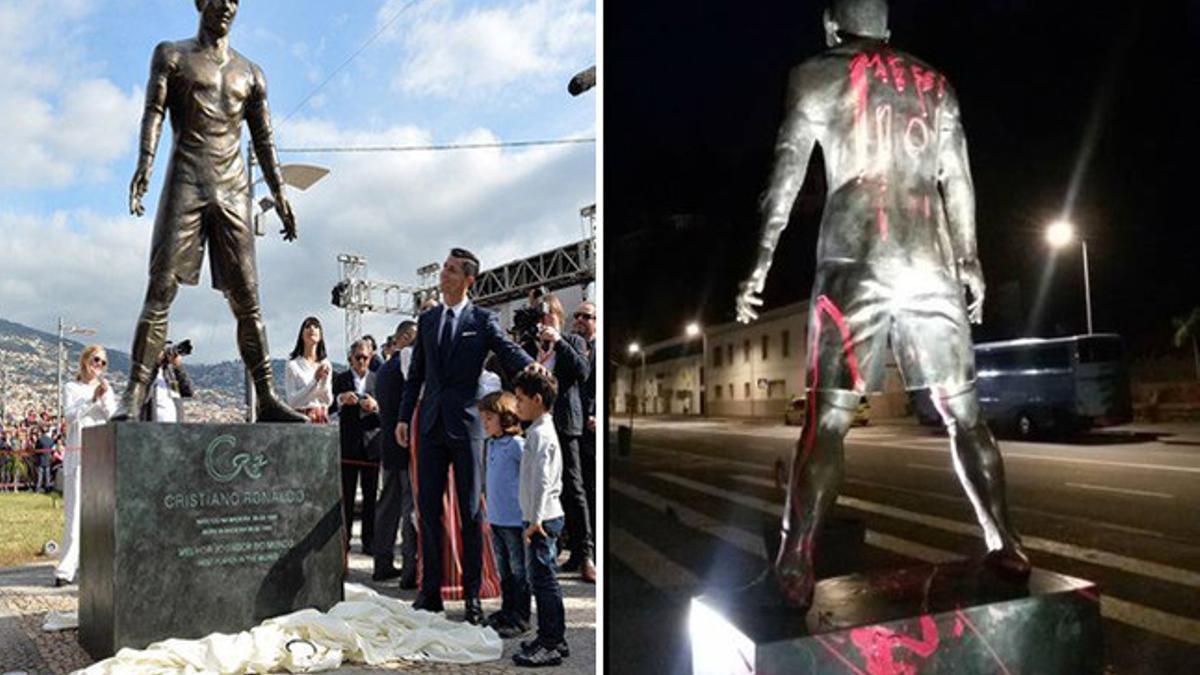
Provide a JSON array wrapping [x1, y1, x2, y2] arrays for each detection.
[[79, 423, 343, 659]]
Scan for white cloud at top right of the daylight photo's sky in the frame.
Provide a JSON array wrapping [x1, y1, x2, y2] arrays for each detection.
[[378, 0, 595, 100]]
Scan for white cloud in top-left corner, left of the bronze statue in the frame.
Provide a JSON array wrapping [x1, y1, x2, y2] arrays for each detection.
[[0, 0, 143, 187]]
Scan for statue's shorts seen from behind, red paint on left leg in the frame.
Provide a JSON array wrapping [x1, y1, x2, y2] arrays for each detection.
[[806, 262, 974, 394]]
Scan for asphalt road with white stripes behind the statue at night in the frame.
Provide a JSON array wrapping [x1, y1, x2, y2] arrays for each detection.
[[605, 419, 1200, 675]]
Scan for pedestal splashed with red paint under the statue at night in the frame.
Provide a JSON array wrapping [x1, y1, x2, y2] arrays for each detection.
[[689, 562, 1103, 675]]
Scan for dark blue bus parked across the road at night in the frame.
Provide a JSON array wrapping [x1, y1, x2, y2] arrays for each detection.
[[916, 334, 1133, 436]]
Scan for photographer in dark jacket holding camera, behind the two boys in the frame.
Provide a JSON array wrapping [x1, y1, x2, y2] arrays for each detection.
[[523, 288, 596, 583]]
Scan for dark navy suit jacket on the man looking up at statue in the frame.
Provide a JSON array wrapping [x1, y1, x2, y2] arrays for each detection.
[[400, 301, 533, 442]]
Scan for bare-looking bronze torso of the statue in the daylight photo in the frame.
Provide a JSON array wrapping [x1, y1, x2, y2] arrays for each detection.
[[155, 40, 262, 191]]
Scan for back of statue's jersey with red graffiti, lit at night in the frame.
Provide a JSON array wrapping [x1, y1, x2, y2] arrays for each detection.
[[787, 41, 961, 269]]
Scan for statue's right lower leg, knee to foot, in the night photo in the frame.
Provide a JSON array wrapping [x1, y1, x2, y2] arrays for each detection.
[[930, 384, 1030, 577]]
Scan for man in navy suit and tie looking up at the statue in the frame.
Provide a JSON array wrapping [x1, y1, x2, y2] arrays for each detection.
[[396, 249, 538, 625]]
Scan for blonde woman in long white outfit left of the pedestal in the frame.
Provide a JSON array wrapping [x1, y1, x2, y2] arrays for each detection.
[[54, 345, 116, 586]]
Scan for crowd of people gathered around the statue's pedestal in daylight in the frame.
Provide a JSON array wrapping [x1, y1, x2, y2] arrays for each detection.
[[34, 249, 596, 665]]
